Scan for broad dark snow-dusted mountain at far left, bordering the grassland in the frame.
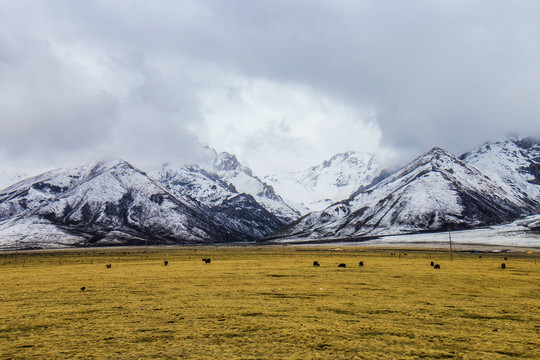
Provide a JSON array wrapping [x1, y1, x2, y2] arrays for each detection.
[[0, 160, 278, 247]]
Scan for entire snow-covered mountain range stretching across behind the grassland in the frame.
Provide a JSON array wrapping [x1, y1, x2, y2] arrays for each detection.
[[0, 139, 540, 248]]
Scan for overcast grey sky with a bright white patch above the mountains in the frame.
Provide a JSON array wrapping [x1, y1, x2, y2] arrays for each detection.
[[0, 0, 540, 175]]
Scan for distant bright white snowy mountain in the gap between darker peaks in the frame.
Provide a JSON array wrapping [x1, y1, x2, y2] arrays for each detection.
[[264, 151, 382, 214]]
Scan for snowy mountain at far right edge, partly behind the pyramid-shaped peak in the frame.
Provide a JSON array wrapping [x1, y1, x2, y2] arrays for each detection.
[[460, 138, 540, 208]]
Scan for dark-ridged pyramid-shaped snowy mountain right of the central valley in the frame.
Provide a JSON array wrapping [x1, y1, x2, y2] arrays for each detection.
[[274, 148, 535, 239]]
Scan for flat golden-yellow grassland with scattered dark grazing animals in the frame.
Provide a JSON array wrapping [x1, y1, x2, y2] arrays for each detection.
[[0, 246, 540, 359]]
